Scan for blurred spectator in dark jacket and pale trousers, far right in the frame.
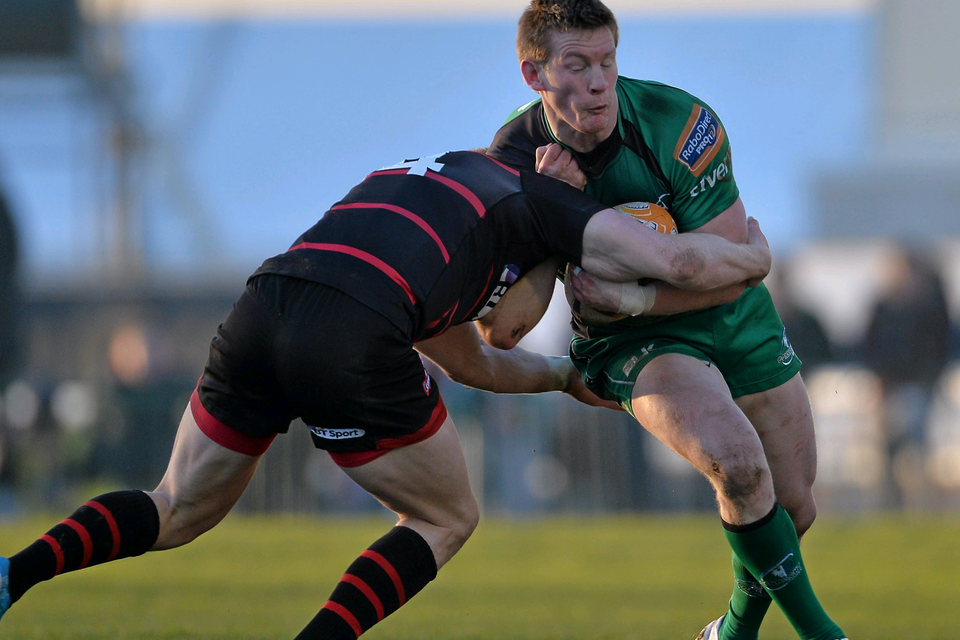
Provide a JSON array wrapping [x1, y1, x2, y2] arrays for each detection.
[[863, 247, 950, 509]]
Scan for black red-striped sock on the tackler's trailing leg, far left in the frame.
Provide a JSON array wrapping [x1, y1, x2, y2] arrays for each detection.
[[10, 491, 160, 602]]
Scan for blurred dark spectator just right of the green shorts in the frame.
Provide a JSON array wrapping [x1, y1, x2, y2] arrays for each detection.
[[768, 261, 834, 370]]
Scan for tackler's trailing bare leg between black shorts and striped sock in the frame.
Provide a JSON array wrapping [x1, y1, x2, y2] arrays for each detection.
[[149, 406, 260, 550]]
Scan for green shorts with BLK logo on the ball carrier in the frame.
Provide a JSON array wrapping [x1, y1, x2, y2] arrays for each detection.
[[570, 284, 800, 411]]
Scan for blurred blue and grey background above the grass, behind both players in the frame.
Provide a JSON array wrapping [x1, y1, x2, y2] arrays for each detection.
[[0, 0, 960, 517]]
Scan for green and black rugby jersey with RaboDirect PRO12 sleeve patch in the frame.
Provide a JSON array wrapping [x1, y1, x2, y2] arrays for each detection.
[[487, 76, 740, 333]]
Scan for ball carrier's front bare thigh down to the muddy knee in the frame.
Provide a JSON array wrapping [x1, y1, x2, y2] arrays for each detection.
[[632, 353, 765, 477]]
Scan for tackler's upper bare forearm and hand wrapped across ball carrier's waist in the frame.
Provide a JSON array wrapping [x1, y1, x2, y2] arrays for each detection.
[[580, 209, 771, 291]]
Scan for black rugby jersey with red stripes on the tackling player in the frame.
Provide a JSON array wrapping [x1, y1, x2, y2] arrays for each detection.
[[251, 151, 605, 340]]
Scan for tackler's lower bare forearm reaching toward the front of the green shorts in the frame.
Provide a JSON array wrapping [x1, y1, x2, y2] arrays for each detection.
[[414, 320, 618, 408]]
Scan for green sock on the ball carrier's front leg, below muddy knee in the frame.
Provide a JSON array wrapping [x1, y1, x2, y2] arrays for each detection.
[[723, 504, 845, 640]]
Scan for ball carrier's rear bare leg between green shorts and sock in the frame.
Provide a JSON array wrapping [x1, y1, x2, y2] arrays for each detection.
[[736, 374, 817, 533]]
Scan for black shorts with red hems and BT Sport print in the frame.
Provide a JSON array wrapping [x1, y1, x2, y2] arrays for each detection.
[[198, 275, 447, 466]]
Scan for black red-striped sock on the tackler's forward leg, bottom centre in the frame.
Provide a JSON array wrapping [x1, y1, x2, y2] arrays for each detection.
[[296, 527, 437, 640]]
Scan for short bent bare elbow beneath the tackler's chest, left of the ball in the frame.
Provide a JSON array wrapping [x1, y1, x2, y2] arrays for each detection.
[[477, 258, 560, 349]]
